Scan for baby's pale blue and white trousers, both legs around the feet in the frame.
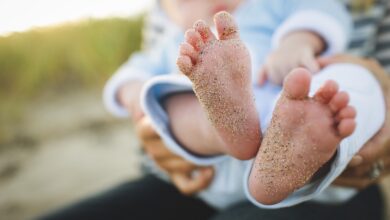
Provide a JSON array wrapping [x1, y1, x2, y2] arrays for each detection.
[[142, 64, 385, 208]]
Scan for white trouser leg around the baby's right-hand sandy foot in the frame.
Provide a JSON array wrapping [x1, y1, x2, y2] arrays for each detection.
[[244, 64, 386, 208]]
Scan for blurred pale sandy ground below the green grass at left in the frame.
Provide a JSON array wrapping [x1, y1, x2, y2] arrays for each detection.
[[0, 92, 140, 220]]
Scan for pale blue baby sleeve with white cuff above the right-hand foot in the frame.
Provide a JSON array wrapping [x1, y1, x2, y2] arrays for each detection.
[[272, 0, 352, 55]]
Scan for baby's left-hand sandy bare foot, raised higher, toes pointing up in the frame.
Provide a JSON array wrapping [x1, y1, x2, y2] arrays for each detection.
[[177, 12, 261, 159]]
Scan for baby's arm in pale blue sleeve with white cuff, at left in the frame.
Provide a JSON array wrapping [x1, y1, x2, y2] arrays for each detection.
[[103, 7, 169, 119]]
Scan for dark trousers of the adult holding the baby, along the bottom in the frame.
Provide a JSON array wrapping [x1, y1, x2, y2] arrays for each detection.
[[40, 175, 384, 220]]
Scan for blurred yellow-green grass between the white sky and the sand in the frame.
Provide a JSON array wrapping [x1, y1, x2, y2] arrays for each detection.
[[0, 16, 143, 139]]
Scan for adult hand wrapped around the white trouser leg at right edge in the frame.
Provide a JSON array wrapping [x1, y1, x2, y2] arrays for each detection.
[[318, 55, 390, 189]]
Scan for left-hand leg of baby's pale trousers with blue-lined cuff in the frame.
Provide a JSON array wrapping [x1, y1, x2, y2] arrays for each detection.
[[141, 75, 280, 209]]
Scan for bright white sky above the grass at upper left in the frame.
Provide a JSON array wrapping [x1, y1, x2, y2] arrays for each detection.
[[0, 0, 153, 35]]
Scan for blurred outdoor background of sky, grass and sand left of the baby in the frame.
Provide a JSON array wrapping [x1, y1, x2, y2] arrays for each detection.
[[0, 0, 152, 220]]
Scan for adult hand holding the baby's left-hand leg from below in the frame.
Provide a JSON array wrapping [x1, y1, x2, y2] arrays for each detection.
[[136, 116, 214, 195]]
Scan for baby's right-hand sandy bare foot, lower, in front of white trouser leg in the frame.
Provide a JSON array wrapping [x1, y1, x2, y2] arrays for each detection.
[[249, 69, 356, 204]]
